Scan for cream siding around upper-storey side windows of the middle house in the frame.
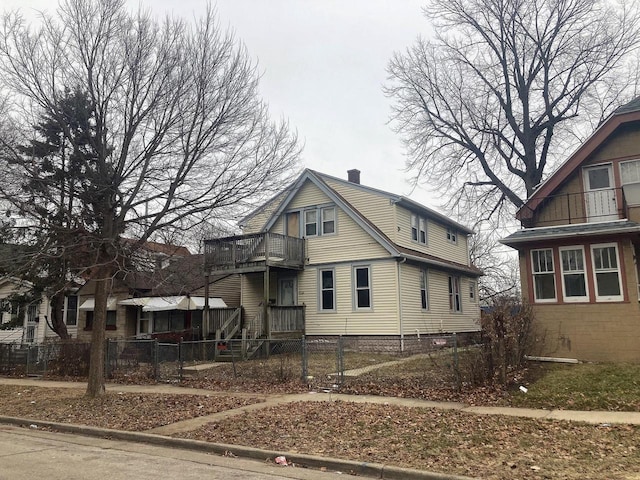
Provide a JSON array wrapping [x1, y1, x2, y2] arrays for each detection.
[[396, 206, 469, 265]]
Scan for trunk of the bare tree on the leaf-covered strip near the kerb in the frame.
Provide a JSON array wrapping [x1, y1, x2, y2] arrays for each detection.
[[86, 266, 111, 398]]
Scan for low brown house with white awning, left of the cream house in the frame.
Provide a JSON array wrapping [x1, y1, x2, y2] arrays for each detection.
[[77, 243, 240, 340]]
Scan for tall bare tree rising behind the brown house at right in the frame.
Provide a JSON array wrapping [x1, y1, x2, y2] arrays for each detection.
[[386, 0, 639, 218]]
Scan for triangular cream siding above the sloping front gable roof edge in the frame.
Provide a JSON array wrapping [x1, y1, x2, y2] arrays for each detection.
[[325, 179, 398, 241]]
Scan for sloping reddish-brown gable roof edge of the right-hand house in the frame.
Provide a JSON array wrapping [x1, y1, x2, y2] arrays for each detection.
[[516, 97, 640, 219]]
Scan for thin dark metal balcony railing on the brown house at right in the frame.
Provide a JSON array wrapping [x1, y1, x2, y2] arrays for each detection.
[[520, 187, 627, 227]]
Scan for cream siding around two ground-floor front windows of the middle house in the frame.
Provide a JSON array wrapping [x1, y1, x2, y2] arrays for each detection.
[[298, 260, 400, 335]]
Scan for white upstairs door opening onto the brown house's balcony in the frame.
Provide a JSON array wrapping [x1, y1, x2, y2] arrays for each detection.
[[583, 165, 618, 222]]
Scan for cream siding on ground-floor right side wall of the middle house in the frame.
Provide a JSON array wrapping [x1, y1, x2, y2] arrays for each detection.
[[400, 263, 480, 335]]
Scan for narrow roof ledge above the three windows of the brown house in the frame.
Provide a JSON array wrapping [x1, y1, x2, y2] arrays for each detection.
[[500, 220, 640, 247]]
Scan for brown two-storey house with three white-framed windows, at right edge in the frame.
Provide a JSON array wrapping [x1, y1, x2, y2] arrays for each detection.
[[502, 97, 640, 361]]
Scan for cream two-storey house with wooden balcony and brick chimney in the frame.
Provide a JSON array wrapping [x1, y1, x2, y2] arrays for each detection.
[[205, 169, 481, 351]]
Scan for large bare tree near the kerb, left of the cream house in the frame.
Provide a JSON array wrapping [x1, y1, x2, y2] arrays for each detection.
[[0, 0, 299, 396]]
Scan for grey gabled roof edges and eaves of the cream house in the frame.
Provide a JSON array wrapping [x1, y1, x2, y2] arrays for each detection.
[[255, 169, 482, 276]]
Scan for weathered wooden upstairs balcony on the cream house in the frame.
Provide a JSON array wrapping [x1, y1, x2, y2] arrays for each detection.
[[204, 232, 305, 274]]
